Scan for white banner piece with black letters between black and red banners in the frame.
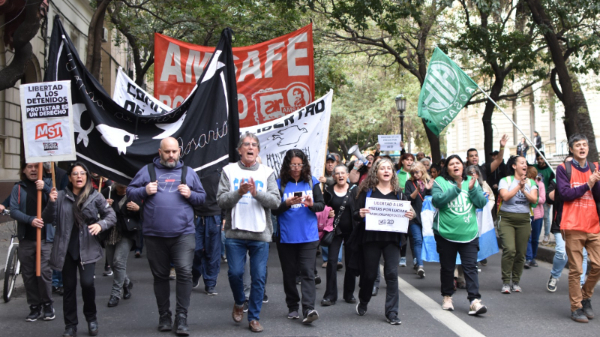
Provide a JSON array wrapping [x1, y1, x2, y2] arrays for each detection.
[[113, 67, 172, 116]]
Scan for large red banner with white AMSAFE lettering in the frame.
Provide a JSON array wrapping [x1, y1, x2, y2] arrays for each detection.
[[154, 24, 315, 127]]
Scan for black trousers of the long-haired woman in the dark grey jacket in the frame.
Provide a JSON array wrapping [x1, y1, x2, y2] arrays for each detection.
[[62, 253, 96, 329]]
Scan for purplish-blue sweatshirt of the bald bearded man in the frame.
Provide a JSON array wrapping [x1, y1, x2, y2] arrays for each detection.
[[127, 157, 206, 238]]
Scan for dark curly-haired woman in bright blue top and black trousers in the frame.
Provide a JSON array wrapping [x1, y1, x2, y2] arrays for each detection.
[[273, 149, 326, 324]]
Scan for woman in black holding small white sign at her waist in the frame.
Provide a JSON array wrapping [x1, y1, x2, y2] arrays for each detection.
[[350, 158, 415, 325]]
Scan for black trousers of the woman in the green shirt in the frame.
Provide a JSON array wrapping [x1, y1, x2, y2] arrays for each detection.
[[435, 235, 481, 302]]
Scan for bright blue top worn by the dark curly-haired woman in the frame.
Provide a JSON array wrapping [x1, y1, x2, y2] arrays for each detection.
[[273, 177, 325, 243]]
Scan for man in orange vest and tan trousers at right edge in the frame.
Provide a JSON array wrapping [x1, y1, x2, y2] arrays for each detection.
[[556, 134, 600, 323]]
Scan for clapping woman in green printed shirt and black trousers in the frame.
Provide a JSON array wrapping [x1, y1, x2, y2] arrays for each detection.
[[432, 155, 487, 315]]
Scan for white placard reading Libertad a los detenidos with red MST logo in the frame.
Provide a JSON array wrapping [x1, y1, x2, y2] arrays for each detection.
[[20, 81, 75, 163]]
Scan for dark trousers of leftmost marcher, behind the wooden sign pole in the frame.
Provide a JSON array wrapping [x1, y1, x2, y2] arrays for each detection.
[[17, 239, 52, 306]]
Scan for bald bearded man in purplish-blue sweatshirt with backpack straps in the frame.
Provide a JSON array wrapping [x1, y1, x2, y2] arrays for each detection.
[[127, 137, 206, 336]]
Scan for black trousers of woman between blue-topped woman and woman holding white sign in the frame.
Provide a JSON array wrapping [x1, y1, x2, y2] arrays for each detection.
[[323, 235, 356, 301]]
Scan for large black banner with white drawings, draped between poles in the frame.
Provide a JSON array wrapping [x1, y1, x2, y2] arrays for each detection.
[[44, 16, 239, 184]]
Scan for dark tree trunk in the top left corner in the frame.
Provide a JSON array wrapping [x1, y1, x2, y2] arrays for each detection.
[[0, 0, 42, 90]]
